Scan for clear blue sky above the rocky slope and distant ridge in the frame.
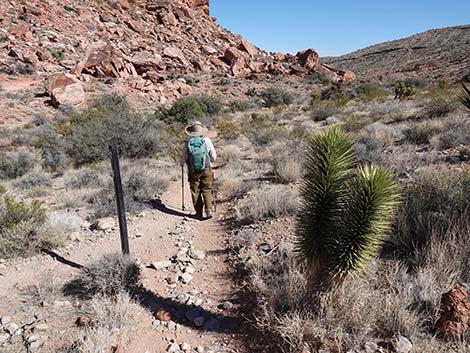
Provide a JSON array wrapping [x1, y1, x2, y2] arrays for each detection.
[[210, 0, 470, 56]]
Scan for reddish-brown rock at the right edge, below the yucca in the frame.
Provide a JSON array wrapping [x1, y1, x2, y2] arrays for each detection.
[[437, 286, 470, 337]]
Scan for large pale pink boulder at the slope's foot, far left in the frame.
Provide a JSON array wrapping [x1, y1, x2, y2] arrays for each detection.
[[46, 73, 86, 107]]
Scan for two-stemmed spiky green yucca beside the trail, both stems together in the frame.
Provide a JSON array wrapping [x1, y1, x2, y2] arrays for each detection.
[[296, 126, 400, 290]]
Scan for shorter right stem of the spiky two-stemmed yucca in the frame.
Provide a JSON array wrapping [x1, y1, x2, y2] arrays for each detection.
[[329, 166, 400, 281]]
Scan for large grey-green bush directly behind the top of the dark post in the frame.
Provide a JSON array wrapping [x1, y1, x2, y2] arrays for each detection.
[[67, 95, 159, 165]]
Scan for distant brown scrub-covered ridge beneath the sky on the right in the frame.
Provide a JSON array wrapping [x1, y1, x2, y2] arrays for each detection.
[[321, 25, 470, 82]]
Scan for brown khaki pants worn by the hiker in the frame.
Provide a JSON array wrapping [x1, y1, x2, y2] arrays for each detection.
[[188, 168, 214, 217]]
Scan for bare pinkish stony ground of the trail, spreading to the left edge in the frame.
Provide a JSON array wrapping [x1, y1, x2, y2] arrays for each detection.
[[0, 177, 268, 352]]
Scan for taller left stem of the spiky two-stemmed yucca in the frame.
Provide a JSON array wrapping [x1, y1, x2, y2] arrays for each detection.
[[296, 126, 356, 276]]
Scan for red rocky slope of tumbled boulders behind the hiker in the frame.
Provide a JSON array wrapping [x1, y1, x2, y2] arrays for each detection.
[[0, 0, 354, 105]]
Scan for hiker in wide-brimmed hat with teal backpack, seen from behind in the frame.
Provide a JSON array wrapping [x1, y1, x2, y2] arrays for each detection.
[[181, 121, 217, 219]]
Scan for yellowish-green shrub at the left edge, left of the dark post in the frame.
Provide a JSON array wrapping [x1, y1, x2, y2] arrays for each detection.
[[0, 196, 63, 258]]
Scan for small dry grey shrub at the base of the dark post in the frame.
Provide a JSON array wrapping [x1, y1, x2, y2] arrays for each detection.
[[64, 254, 141, 297]]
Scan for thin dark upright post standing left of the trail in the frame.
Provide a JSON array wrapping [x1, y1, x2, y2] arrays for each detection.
[[109, 144, 129, 255]]
